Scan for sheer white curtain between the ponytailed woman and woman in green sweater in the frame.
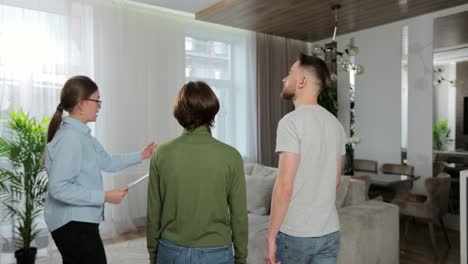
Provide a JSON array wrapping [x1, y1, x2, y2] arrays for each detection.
[[90, 1, 186, 237]]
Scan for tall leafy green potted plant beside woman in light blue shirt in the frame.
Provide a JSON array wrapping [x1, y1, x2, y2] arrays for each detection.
[[0, 110, 48, 264]]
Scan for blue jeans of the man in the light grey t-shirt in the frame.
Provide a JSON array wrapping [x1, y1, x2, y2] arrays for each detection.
[[276, 232, 340, 264]]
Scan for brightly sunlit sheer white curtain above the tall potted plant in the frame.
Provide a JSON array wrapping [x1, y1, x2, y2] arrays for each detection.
[[0, 0, 94, 263]]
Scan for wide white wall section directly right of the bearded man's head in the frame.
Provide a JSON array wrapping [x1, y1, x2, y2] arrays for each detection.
[[310, 20, 401, 168]]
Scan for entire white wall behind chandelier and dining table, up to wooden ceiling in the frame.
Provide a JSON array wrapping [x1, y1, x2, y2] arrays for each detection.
[[312, 4, 468, 193]]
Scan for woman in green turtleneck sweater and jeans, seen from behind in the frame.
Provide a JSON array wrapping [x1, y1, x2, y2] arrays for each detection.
[[147, 82, 248, 264]]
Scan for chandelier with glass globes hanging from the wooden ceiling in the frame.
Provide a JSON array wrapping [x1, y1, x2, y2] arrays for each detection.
[[312, 4, 364, 79]]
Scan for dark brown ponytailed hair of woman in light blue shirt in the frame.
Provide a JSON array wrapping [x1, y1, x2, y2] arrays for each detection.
[[47, 76, 98, 142]]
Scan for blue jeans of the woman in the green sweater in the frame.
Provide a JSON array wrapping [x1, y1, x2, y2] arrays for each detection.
[[156, 238, 234, 264]]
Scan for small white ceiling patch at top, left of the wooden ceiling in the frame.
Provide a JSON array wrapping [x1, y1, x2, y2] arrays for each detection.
[[133, 0, 220, 14]]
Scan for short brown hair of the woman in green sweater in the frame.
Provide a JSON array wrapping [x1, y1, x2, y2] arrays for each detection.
[[174, 82, 219, 130]]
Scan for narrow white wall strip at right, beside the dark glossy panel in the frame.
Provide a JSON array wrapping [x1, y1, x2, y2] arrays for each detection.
[[407, 13, 433, 193]]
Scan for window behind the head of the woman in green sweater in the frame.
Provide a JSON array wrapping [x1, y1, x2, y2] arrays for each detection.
[[185, 32, 257, 162]]
